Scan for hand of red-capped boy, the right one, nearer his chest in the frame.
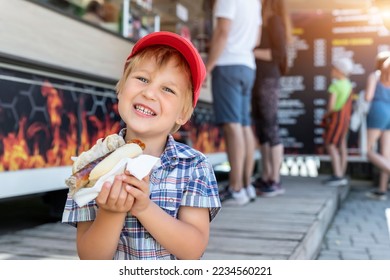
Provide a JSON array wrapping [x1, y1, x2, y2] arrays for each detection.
[[124, 171, 151, 217]]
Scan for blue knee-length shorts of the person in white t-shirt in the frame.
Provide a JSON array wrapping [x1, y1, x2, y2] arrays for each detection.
[[212, 65, 255, 126]]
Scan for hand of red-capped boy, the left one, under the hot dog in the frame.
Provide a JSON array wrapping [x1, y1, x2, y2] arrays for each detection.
[[96, 175, 134, 213]]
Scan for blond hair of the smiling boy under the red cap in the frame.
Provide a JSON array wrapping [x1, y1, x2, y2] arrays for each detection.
[[115, 45, 194, 133]]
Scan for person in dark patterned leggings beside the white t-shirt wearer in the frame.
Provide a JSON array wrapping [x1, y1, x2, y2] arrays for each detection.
[[252, 0, 292, 197]]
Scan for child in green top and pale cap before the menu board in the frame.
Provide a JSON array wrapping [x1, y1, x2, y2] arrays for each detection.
[[324, 58, 353, 186]]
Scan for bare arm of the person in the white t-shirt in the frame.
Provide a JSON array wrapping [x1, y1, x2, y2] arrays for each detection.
[[206, 18, 231, 74]]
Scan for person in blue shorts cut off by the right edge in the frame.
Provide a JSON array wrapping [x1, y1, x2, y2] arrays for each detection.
[[365, 52, 390, 200]]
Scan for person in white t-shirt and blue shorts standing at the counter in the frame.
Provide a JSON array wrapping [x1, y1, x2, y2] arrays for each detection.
[[206, 0, 261, 206]]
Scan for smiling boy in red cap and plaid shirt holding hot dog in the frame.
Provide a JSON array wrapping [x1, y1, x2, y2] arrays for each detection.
[[63, 32, 220, 260]]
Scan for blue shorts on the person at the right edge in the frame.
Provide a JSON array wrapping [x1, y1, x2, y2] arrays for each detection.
[[367, 101, 390, 130]]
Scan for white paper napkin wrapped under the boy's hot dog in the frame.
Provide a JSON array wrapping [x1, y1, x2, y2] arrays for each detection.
[[73, 155, 160, 207]]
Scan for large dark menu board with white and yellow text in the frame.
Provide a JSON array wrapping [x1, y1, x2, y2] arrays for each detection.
[[278, 9, 390, 155]]
